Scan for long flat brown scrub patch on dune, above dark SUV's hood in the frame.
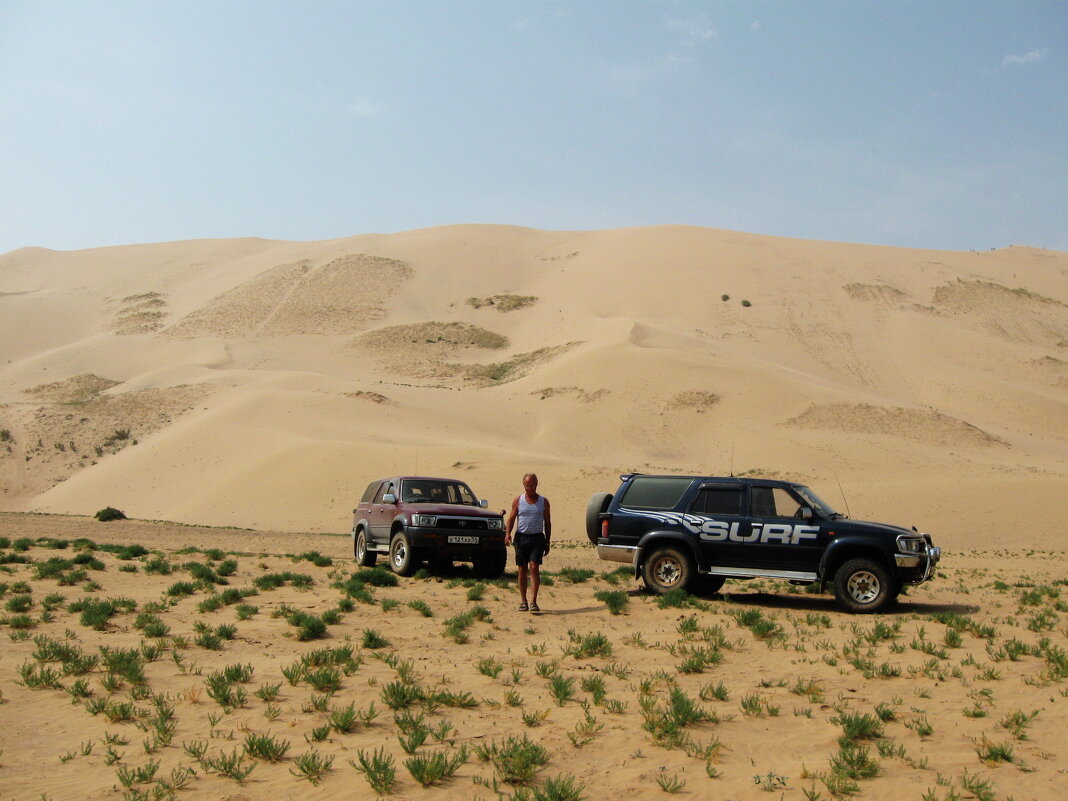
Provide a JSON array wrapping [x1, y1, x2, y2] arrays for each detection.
[[786, 404, 1006, 446]]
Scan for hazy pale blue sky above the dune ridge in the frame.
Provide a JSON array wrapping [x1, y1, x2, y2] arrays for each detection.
[[0, 0, 1068, 253]]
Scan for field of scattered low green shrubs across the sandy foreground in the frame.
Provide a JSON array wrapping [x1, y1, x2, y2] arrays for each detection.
[[0, 521, 1068, 801]]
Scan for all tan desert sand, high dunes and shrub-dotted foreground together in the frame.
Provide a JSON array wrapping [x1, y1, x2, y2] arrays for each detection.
[[0, 225, 1068, 801]]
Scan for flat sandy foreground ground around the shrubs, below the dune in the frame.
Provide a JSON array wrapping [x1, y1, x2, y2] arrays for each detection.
[[0, 514, 1068, 801]]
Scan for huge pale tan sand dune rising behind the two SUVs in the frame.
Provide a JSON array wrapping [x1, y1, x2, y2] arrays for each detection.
[[0, 225, 1068, 538]]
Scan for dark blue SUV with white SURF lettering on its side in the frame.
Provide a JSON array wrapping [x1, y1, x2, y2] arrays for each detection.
[[586, 473, 941, 612]]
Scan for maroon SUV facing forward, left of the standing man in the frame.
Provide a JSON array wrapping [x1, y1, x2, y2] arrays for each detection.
[[352, 475, 507, 579]]
